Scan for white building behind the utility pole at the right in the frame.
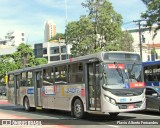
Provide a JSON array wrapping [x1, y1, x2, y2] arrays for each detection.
[[127, 26, 160, 61]]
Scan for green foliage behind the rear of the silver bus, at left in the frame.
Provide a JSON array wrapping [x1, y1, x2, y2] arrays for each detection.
[[0, 43, 47, 80]]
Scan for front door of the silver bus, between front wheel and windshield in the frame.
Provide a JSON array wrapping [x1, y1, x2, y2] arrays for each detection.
[[87, 62, 101, 111]]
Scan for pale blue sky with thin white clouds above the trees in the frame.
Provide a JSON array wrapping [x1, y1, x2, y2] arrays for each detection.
[[0, 0, 146, 45]]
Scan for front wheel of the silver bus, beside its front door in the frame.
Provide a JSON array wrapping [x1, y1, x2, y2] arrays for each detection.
[[72, 99, 85, 119]]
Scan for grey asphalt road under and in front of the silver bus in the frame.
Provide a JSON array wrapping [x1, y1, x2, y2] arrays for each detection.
[[0, 99, 160, 128]]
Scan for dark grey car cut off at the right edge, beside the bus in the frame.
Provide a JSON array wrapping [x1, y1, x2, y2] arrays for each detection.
[[146, 86, 160, 112]]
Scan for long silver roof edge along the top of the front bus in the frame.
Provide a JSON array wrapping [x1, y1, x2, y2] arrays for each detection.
[[8, 51, 139, 74]]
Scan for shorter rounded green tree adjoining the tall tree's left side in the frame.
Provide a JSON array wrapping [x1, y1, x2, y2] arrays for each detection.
[[66, 16, 95, 56]]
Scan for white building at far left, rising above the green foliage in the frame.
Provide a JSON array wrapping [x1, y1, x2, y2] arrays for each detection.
[[5, 30, 25, 46]]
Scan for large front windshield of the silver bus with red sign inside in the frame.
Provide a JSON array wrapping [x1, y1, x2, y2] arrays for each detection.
[[104, 64, 142, 88]]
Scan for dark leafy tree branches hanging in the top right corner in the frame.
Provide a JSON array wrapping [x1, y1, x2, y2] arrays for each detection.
[[141, 0, 160, 36]]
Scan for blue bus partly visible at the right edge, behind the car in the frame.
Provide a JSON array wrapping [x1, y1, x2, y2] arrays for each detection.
[[142, 60, 160, 86]]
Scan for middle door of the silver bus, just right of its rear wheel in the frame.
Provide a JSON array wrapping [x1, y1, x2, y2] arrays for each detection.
[[34, 70, 42, 107]]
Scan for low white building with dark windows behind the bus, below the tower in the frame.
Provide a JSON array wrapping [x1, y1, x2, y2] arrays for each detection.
[[34, 40, 71, 63]]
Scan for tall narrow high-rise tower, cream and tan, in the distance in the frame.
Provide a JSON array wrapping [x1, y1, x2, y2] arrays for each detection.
[[44, 20, 56, 42]]
